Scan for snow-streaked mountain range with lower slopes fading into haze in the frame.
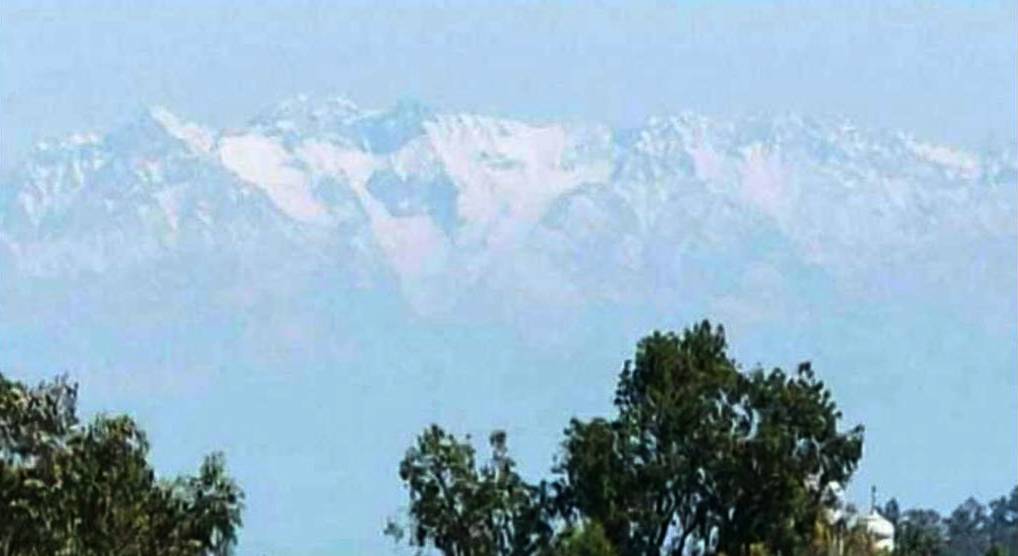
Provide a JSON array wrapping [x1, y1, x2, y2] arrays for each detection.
[[0, 97, 1018, 307]]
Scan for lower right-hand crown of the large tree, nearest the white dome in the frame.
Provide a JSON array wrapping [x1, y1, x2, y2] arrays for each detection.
[[708, 363, 862, 554]]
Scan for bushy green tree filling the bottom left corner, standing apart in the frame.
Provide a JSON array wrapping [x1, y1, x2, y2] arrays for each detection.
[[0, 375, 243, 556]]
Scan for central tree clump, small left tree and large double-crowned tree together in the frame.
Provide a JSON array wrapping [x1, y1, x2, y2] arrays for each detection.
[[392, 322, 862, 556]]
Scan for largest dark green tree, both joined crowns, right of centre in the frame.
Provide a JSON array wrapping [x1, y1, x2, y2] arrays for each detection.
[[555, 322, 862, 555]]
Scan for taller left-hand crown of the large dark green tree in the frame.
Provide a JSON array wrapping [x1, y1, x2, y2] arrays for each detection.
[[555, 323, 748, 555]]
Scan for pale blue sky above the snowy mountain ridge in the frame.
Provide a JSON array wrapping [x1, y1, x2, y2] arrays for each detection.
[[0, 0, 1018, 169]]
